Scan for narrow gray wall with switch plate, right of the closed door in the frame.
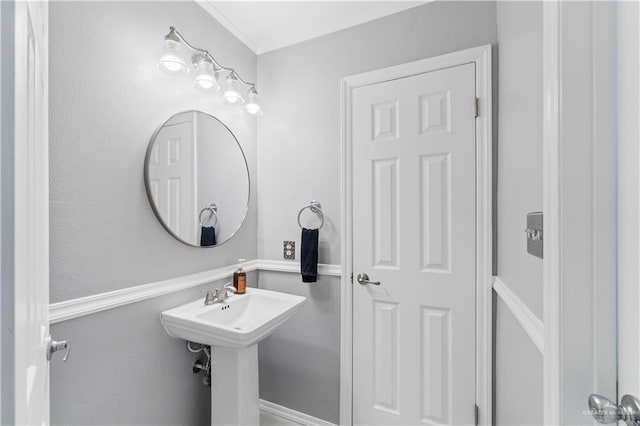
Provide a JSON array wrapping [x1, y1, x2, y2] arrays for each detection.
[[495, 2, 542, 425]]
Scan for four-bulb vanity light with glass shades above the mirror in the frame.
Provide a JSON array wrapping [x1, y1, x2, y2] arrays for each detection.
[[158, 27, 262, 116]]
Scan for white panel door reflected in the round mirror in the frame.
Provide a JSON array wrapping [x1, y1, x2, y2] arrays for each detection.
[[149, 121, 200, 245]]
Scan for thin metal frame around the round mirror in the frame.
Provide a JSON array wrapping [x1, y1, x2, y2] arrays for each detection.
[[144, 109, 251, 249]]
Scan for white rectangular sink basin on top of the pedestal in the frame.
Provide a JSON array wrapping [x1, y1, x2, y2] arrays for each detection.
[[160, 288, 305, 349]]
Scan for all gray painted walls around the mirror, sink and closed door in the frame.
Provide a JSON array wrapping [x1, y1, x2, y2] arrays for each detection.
[[50, 2, 552, 424]]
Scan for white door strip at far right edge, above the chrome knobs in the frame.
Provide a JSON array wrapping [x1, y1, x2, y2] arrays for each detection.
[[616, 3, 640, 398]]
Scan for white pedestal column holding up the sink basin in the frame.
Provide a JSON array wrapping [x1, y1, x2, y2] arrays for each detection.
[[211, 344, 260, 426]]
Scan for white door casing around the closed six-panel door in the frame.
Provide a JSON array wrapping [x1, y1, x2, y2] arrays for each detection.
[[340, 45, 493, 425]]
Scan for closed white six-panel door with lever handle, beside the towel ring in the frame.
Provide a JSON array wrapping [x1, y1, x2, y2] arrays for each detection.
[[352, 64, 476, 425]]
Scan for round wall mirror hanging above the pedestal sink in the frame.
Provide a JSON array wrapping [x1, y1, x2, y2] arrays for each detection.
[[144, 111, 249, 247]]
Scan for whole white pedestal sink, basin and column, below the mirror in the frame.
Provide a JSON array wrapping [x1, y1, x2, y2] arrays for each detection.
[[160, 288, 305, 425]]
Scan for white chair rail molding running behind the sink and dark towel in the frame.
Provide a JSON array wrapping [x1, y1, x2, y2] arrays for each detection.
[[49, 259, 342, 324]]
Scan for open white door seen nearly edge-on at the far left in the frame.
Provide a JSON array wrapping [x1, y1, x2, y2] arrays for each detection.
[[13, 1, 49, 425]]
